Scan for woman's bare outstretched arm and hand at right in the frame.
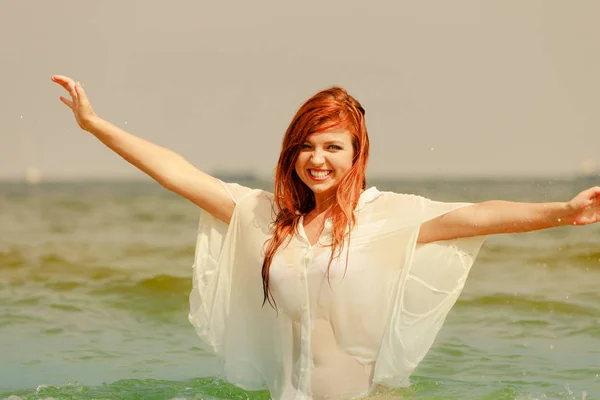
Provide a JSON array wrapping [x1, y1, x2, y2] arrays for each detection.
[[417, 186, 600, 243]]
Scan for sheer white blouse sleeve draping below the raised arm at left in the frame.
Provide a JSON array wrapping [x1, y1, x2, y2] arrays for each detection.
[[189, 184, 284, 393]]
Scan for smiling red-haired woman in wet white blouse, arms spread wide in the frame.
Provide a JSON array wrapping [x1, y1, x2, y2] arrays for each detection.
[[52, 76, 600, 399]]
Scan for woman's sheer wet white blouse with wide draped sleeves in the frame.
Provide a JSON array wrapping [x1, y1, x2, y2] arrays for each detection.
[[189, 184, 484, 400]]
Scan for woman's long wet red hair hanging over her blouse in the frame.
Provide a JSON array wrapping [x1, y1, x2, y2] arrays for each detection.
[[262, 87, 369, 309]]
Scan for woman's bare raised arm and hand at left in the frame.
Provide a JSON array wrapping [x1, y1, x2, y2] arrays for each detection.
[[52, 75, 235, 223]]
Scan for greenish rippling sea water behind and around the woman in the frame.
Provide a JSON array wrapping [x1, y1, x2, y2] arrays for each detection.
[[0, 180, 600, 400]]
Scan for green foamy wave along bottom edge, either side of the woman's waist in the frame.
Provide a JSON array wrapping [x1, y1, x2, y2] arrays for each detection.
[[0, 371, 589, 400]]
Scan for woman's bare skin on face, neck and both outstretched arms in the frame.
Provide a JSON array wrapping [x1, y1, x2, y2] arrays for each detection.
[[52, 75, 600, 243]]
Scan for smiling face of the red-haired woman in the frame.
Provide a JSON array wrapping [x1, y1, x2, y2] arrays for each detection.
[[295, 129, 354, 204]]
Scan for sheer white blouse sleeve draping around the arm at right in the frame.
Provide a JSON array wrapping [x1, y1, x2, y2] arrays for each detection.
[[373, 196, 485, 387]]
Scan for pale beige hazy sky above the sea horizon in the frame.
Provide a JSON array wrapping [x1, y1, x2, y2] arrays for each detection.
[[0, 0, 600, 179]]
